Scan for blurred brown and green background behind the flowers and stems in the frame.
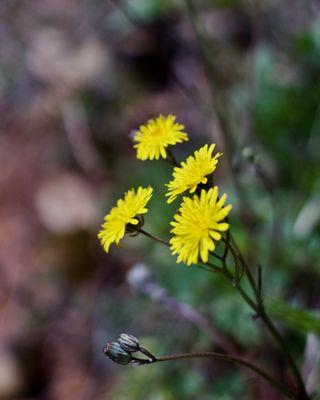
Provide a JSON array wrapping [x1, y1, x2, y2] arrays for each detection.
[[0, 0, 320, 400]]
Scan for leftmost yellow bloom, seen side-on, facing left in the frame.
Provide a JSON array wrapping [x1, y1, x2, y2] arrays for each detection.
[[98, 186, 153, 253]]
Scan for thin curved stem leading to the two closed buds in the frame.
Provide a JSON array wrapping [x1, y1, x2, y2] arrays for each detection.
[[153, 352, 296, 399]]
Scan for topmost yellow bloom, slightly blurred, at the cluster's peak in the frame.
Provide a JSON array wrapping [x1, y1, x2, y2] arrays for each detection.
[[133, 115, 189, 161]]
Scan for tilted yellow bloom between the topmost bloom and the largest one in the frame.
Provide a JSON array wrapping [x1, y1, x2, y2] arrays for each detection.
[[166, 144, 222, 203]]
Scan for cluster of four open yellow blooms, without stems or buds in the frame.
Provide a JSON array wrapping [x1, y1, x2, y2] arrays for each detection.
[[98, 115, 232, 265]]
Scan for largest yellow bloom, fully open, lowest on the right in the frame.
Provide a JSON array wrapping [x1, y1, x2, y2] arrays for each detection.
[[170, 186, 232, 265]]
